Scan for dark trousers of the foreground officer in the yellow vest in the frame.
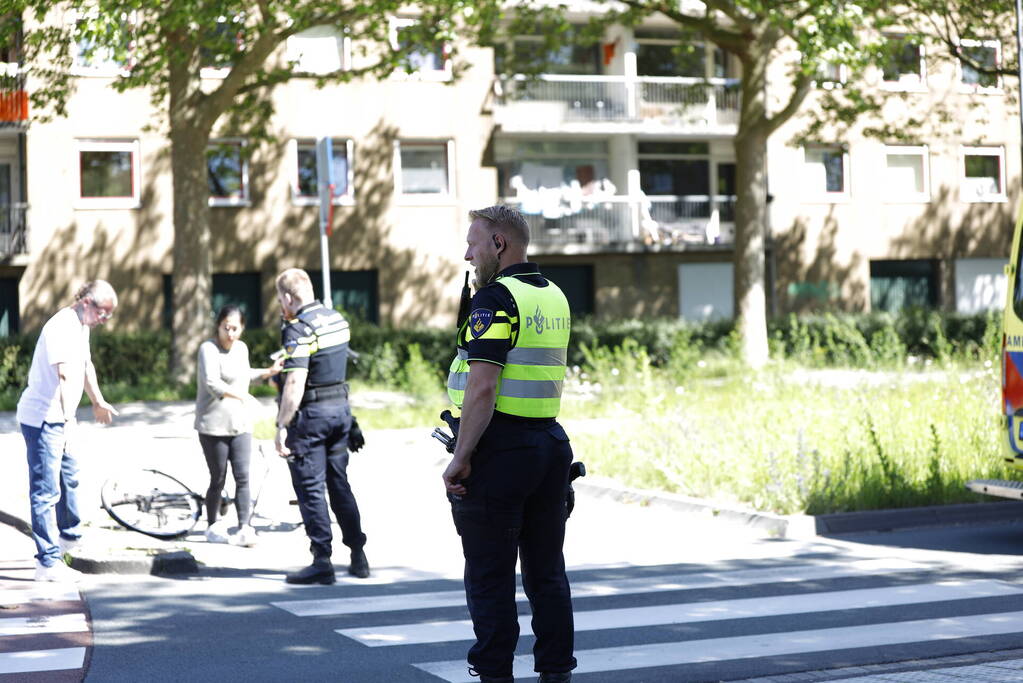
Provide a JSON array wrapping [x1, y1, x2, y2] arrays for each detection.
[[448, 414, 576, 677]]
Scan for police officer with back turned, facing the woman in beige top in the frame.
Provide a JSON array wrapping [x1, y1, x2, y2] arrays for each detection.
[[275, 268, 369, 584]]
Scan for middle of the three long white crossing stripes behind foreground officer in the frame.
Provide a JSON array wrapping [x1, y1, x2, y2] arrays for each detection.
[[337, 580, 1023, 647]]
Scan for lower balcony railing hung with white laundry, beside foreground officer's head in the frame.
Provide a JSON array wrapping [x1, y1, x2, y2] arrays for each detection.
[[503, 194, 736, 255]]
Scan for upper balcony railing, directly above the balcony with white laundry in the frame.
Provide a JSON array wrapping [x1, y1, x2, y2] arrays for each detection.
[[494, 75, 740, 135]]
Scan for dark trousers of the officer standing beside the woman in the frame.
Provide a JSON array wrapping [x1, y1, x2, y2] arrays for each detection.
[[285, 399, 366, 557]]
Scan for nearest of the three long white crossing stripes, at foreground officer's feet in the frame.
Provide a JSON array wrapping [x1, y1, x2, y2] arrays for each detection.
[[412, 611, 1023, 683]]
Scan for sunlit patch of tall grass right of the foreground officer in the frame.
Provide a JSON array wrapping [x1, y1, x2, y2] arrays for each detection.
[[566, 364, 1007, 514]]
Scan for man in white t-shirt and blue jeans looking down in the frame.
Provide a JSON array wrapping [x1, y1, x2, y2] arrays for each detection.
[[17, 280, 118, 581]]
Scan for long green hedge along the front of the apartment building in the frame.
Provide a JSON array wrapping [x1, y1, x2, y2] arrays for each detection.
[[0, 310, 1002, 395]]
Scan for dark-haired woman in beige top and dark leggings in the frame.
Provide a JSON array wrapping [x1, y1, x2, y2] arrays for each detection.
[[195, 305, 281, 546]]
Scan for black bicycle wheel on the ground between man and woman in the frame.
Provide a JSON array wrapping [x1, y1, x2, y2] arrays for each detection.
[[99, 469, 203, 539]]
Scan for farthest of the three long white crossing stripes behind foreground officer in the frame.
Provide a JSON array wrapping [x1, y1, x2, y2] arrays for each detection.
[[270, 559, 924, 617]]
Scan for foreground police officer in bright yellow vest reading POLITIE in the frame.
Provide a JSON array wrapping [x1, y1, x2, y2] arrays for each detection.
[[443, 206, 576, 683]]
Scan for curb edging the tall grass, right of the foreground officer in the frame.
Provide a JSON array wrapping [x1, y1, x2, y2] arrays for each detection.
[[572, 479, 1023, 539]]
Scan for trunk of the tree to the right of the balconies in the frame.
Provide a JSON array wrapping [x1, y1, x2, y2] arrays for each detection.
[[735, 47, 768, 368]]
